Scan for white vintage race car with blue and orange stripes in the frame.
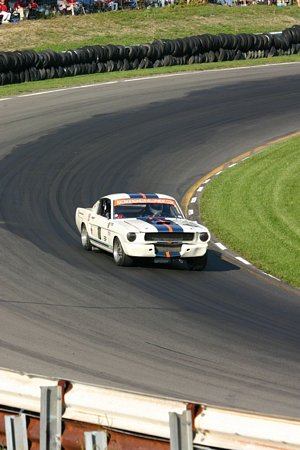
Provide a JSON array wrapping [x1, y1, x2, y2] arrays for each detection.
[[75, 193, 210, 270]]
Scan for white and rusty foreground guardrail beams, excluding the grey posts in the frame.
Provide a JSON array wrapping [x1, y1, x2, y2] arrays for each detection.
[[0, 369, 300, 450]]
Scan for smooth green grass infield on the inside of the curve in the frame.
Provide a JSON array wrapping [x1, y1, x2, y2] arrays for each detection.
[[201, 137, 300, 287]]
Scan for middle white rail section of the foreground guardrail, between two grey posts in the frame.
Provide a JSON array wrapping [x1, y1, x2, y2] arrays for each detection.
[[63, 383, 187, 439]]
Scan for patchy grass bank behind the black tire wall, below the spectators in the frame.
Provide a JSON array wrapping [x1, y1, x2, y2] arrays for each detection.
[[0, 5, 300, 51]]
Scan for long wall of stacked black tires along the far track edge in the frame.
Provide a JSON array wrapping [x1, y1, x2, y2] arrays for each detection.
[[0, 25, 300, 85]]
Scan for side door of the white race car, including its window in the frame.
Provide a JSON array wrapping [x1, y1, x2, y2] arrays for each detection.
[[90, 198, 111, 248]]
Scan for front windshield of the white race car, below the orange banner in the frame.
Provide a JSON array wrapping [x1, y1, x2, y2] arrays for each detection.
[[114, 202, 183, 219]]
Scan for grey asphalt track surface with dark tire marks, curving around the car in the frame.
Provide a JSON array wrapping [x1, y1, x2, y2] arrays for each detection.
[[0, 64, 300, 417]]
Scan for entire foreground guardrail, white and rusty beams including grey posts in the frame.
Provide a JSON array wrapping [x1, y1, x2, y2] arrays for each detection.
[[0, 370, 300, 450]]
